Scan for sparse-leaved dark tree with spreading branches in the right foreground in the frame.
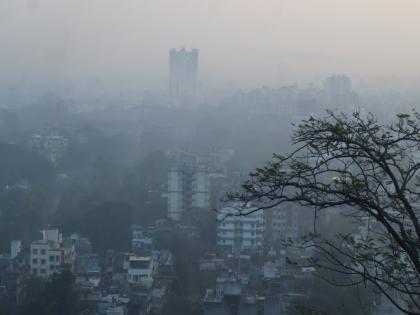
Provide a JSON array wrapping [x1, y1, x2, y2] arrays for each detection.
[[230, 111, 420, 314]]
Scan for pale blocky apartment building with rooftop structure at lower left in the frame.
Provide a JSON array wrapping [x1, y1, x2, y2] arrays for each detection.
[[30, 229, 75, 277]]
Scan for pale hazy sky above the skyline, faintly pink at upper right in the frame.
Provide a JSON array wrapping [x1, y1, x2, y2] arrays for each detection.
[[0, 0, 420, 90]]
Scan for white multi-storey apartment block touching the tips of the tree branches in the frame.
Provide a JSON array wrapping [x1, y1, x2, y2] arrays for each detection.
[[217, 205, 264, 254]]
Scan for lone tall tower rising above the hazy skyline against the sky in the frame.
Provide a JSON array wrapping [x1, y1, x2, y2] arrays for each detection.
[[169, 48, 198, 106]]
